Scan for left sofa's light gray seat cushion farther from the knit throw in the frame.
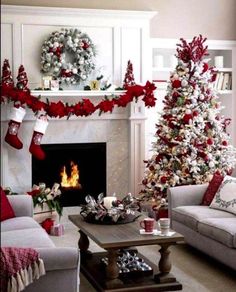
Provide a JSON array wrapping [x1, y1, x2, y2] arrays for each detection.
[[1, 217, 41, 232]]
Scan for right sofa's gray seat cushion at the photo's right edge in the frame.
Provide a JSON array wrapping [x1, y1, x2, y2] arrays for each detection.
[[198, 216, 236, 248]]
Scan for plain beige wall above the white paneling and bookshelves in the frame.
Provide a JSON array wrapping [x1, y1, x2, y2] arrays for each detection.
[[1, 0, 236, 40]]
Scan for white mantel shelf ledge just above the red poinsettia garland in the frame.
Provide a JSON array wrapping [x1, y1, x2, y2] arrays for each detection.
[[31, 90, 126, 97]]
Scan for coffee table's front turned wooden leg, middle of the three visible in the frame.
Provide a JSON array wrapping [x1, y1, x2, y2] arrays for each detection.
[[106, 249, 123, 289]]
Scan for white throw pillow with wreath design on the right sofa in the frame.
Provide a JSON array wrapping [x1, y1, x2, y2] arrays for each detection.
[[210, 175, 236, 215]]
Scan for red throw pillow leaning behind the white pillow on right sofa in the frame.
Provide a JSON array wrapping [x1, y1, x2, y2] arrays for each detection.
[[201, 173, 224, 206]]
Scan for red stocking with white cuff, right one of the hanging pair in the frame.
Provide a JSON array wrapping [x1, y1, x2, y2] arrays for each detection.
[[29, 116, 48, 160]]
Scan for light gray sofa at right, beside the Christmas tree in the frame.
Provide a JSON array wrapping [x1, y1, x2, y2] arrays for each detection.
[[168, 184, 236, 270]]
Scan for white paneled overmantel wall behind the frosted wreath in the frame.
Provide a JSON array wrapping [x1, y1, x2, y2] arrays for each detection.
[[1, 6, 155, 89]]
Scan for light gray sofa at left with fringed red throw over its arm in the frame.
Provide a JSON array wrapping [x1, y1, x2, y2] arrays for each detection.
[[1, 195, 79, 292]]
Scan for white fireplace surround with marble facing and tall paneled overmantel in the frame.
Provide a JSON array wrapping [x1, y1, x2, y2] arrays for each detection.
[[1, 5, 156, 195]]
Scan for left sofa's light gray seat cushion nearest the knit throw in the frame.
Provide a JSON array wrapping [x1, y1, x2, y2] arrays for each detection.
[[1, 228, 55, 248]]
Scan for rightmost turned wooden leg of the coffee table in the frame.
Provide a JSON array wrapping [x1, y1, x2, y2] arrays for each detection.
[[154, 243, 176, 283]]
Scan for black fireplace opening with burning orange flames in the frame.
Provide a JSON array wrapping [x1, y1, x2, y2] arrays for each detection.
[[32, 143, 106, 207]]
